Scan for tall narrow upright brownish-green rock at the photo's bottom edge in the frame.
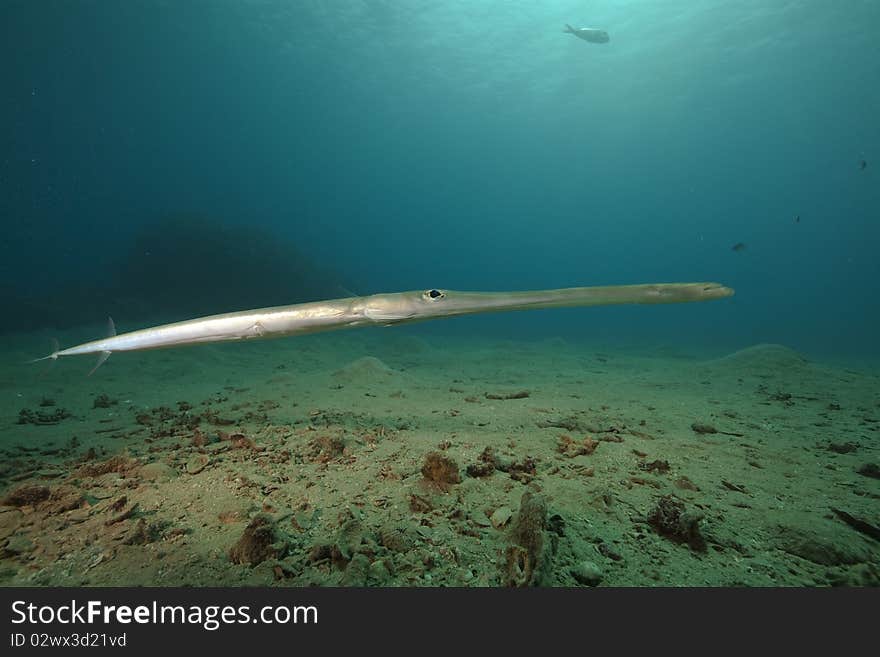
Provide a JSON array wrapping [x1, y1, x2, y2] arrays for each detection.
[[502, 491, 555, 587]]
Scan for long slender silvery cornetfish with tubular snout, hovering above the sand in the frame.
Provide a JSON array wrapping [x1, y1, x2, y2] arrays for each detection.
[[36, 283, 733, 372]]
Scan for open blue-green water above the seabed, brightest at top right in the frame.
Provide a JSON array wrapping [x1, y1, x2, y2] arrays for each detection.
[[0, 0, 880, 359]]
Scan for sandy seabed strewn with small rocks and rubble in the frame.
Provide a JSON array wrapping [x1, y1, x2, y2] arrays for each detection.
[[0, 330, 880, 586]]
